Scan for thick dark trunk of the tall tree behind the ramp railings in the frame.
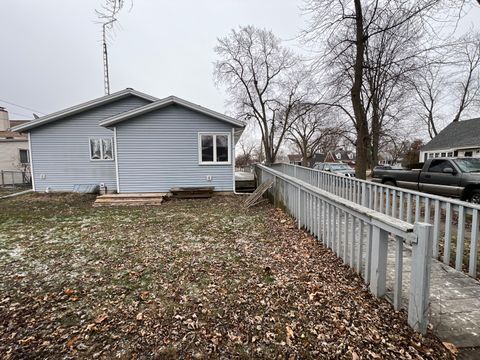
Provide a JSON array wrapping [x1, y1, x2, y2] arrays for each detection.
[[350, 0, 369, 179]]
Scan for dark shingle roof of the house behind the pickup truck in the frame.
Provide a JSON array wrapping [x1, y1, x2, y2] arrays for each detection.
[[422, 118, 480, 151]]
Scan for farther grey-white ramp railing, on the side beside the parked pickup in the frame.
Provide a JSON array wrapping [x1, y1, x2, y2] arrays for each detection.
[[272, 164, 480, 278]]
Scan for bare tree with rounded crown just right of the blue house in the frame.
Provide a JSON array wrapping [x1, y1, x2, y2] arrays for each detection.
[[214, 26, 316, 164]]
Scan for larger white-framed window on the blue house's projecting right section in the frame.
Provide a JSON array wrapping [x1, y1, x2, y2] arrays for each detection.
[[198, 133, 230, 164]]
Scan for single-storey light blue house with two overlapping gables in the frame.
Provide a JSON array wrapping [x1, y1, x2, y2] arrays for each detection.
[[14, 89, 244, 193]]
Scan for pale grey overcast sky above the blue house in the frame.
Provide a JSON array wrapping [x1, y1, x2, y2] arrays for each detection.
[[0, 0, 480, 119]]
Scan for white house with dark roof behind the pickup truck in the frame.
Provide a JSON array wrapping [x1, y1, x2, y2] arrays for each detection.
[[419, 118, 480, 162]]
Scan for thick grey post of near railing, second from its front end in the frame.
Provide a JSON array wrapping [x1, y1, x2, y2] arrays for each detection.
[[370, 225, 388, 297]]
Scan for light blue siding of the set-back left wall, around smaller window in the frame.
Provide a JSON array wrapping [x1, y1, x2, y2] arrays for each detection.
[[30, 96, 149, 191]]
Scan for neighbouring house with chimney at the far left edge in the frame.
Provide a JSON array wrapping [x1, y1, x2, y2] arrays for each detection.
[[0, 107, 30, 174]]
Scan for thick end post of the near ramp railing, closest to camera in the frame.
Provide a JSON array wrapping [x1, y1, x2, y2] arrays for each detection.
[[408, 223, 433, 334]]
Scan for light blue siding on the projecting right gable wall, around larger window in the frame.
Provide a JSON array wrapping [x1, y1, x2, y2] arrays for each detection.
[[116, 105, 234, 193]]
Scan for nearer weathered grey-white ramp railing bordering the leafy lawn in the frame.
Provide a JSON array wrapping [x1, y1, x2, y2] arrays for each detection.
[[256, 165, 433, 333]]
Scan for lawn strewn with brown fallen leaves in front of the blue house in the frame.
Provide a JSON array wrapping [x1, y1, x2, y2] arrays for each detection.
[[0, 194, 452, 359]]
